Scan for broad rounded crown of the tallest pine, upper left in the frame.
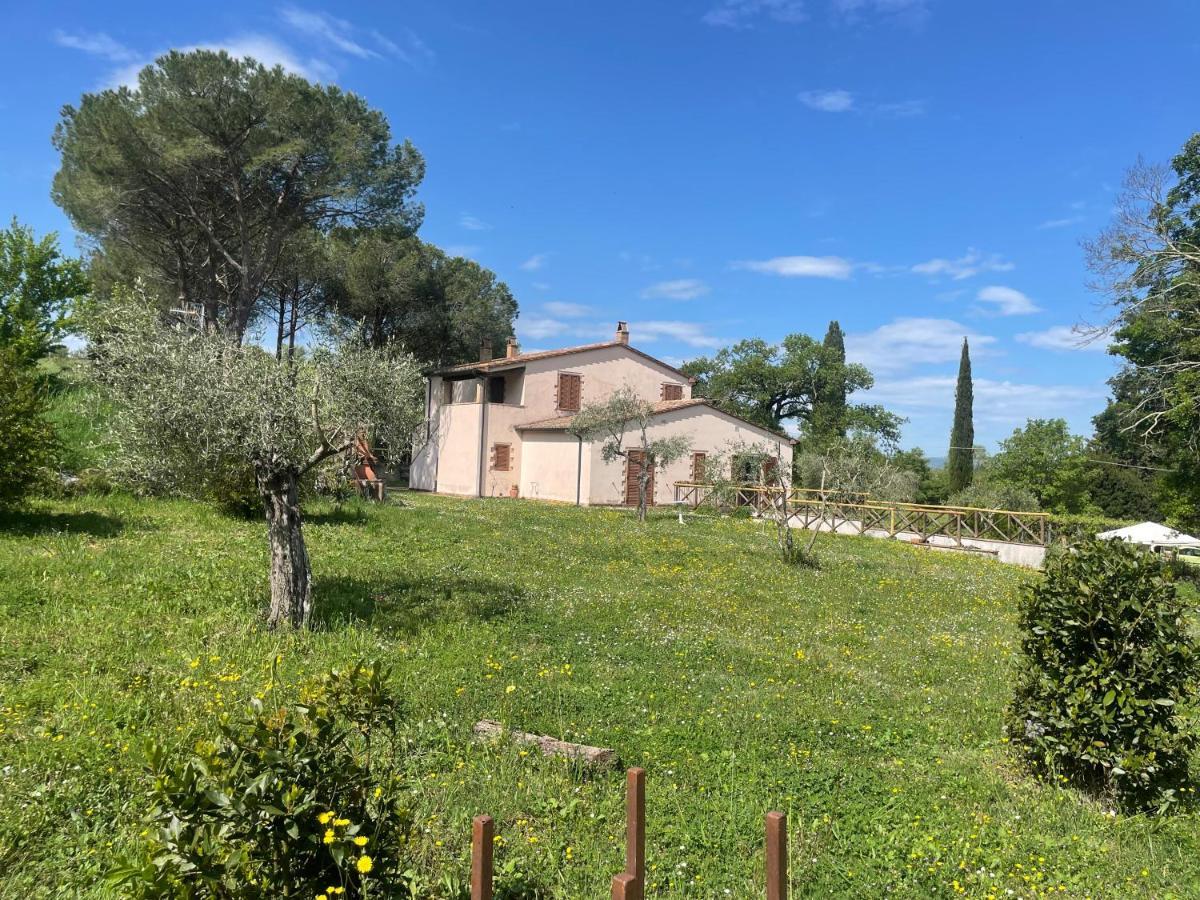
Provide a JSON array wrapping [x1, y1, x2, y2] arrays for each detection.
[[53, 50, 424, 341]]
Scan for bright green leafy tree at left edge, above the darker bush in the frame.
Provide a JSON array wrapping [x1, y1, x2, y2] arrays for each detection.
[[0, 218, 89, 366]]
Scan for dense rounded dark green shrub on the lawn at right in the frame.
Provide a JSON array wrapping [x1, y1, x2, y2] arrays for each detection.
[[1008, 540, 1196, 810]]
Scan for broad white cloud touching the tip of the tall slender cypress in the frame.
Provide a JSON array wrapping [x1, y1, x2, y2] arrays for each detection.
[[846, 318, 996, 372]]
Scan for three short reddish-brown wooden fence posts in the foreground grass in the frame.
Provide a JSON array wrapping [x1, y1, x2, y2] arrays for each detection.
[[470, 768, 787, 900]]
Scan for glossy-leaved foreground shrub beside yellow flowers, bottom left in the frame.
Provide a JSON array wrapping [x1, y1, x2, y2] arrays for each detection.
[[112, 665, 412, 900]]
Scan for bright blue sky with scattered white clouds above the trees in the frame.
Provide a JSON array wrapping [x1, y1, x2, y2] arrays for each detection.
[[0, 0, 1200, 456]]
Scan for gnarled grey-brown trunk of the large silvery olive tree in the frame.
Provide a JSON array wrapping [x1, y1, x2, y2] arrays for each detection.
[[254, 467, 312, 629]]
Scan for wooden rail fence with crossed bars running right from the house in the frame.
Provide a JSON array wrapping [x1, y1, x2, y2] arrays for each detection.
[[674, 481, 1051, 546]]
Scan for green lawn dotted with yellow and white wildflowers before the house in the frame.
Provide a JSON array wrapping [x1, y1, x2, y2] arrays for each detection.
[[0, 496, 1200, 899]]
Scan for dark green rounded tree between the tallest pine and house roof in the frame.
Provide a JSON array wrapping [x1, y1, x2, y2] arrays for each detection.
[[335, 229, 517, 366]]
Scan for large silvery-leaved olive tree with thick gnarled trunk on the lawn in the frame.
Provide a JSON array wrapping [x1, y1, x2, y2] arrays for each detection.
[[88, 292, 421, 628]]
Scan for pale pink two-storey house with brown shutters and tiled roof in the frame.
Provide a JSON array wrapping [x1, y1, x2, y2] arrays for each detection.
[[409, 322, 792, 505]]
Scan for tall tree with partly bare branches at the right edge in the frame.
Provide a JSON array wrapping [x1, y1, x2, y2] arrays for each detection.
[[1085, 145, 1200, 527]]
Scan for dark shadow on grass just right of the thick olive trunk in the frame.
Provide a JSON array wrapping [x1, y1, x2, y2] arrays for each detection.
[[313, 576, 528, 635]]
